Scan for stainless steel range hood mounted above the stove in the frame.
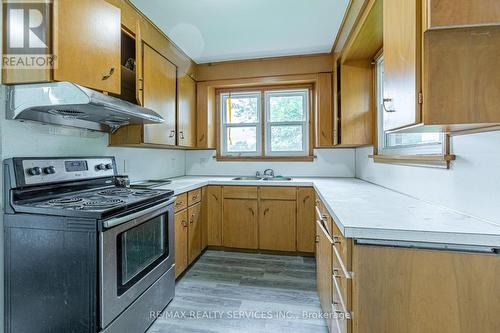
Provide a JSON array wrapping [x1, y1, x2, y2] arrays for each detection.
[[7, 82, 164, 132]]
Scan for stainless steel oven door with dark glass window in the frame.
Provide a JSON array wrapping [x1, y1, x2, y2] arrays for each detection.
[[99, 199, 175, 329]]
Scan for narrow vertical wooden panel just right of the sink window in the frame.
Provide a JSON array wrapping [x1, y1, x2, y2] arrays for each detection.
[[315, 73, 333, 147]]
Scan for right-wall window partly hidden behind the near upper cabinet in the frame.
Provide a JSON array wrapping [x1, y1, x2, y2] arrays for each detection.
[[376, 56, 445, 155]]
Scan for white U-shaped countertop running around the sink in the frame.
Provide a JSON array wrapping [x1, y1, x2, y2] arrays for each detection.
[[156, 177, 500, 247]]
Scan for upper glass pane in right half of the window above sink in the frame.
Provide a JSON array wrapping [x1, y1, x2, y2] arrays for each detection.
[[269, 94, 305, 122]]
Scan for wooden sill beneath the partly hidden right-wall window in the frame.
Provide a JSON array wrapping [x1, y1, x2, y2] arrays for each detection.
[[369, 154, 456, 169]]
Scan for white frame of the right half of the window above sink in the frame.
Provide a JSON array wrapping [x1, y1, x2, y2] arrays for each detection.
[[264, 89, 309, 157]]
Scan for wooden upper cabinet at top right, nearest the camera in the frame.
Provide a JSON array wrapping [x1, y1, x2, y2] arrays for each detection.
[[383, 0, 500, 132]]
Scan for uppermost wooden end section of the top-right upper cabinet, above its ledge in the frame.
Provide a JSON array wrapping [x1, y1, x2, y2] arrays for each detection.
[[424, 0, 500, 29]]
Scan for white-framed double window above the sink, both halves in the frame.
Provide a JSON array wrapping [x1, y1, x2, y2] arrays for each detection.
[[220, 89, 310, 157]]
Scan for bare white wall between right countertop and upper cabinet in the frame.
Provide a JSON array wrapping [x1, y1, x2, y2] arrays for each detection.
[[356, 132, 500, 223]]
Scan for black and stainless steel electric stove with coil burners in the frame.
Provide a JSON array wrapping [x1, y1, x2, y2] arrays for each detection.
[[4, 157, 175, 333]]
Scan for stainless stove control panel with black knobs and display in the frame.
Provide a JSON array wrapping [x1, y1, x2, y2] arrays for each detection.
[[20, 157, 117, 185]]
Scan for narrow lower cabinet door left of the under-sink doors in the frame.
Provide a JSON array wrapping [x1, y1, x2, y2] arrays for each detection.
[[207, 186, 222, 246]]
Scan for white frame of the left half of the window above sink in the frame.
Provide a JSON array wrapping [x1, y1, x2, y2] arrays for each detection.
[[220, 91, 262, 157]]
